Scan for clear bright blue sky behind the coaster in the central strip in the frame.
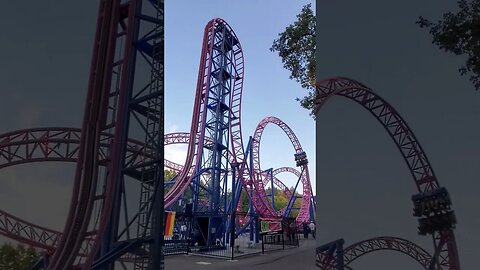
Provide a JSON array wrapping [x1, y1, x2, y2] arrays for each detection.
[[165, 0, 315, 194]]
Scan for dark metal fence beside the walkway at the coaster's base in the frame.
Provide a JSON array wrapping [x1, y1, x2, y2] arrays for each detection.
[[165, 212, 299, 260]]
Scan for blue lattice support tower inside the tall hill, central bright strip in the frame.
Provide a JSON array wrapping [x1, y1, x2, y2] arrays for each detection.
[[197, 22, 238, 211]]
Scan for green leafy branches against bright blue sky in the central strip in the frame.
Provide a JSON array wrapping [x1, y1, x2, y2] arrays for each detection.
[[270, 4, 315, 116]]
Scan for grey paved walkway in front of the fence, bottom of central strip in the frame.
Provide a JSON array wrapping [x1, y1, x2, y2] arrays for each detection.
[[165, 238, 318, 270]]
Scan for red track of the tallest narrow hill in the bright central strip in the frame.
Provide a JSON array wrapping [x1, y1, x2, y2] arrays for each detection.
[[165, 18, 286, 221]]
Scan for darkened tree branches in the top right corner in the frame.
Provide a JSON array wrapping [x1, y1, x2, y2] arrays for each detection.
[[417, 0, 480, 90]]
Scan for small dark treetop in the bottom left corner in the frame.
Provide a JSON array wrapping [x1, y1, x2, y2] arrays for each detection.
[[0, 243, 40, 270]]
